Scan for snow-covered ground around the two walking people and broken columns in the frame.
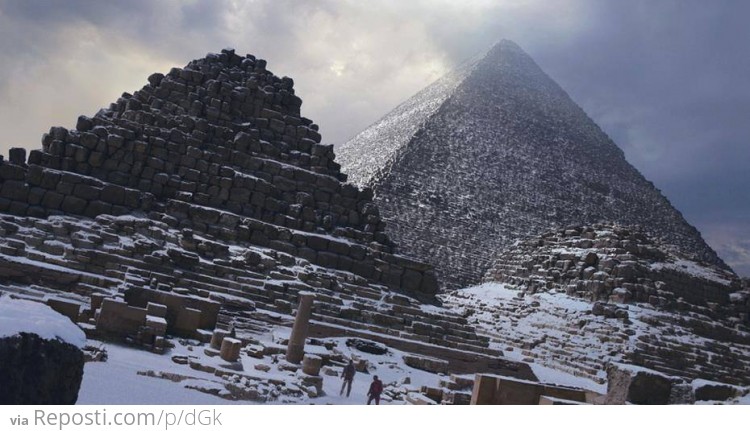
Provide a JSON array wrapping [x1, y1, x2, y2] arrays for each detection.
[[78, 329, 458, 404]]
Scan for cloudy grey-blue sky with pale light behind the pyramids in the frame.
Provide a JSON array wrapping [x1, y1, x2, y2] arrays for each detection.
[[0, 0, 750, 275]]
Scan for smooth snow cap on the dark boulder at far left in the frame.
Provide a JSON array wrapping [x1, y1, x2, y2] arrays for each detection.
[[0, 295, 86, 348]]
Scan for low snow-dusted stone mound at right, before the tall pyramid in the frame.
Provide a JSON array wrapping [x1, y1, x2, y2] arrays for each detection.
[[444, 224, 750, 385]]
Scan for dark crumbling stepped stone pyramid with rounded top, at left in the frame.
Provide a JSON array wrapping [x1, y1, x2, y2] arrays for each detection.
[[0, 50, 533, 398]]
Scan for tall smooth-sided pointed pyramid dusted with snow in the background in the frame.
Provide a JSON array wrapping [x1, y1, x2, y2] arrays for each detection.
[[337, 40, 727, 288]]
